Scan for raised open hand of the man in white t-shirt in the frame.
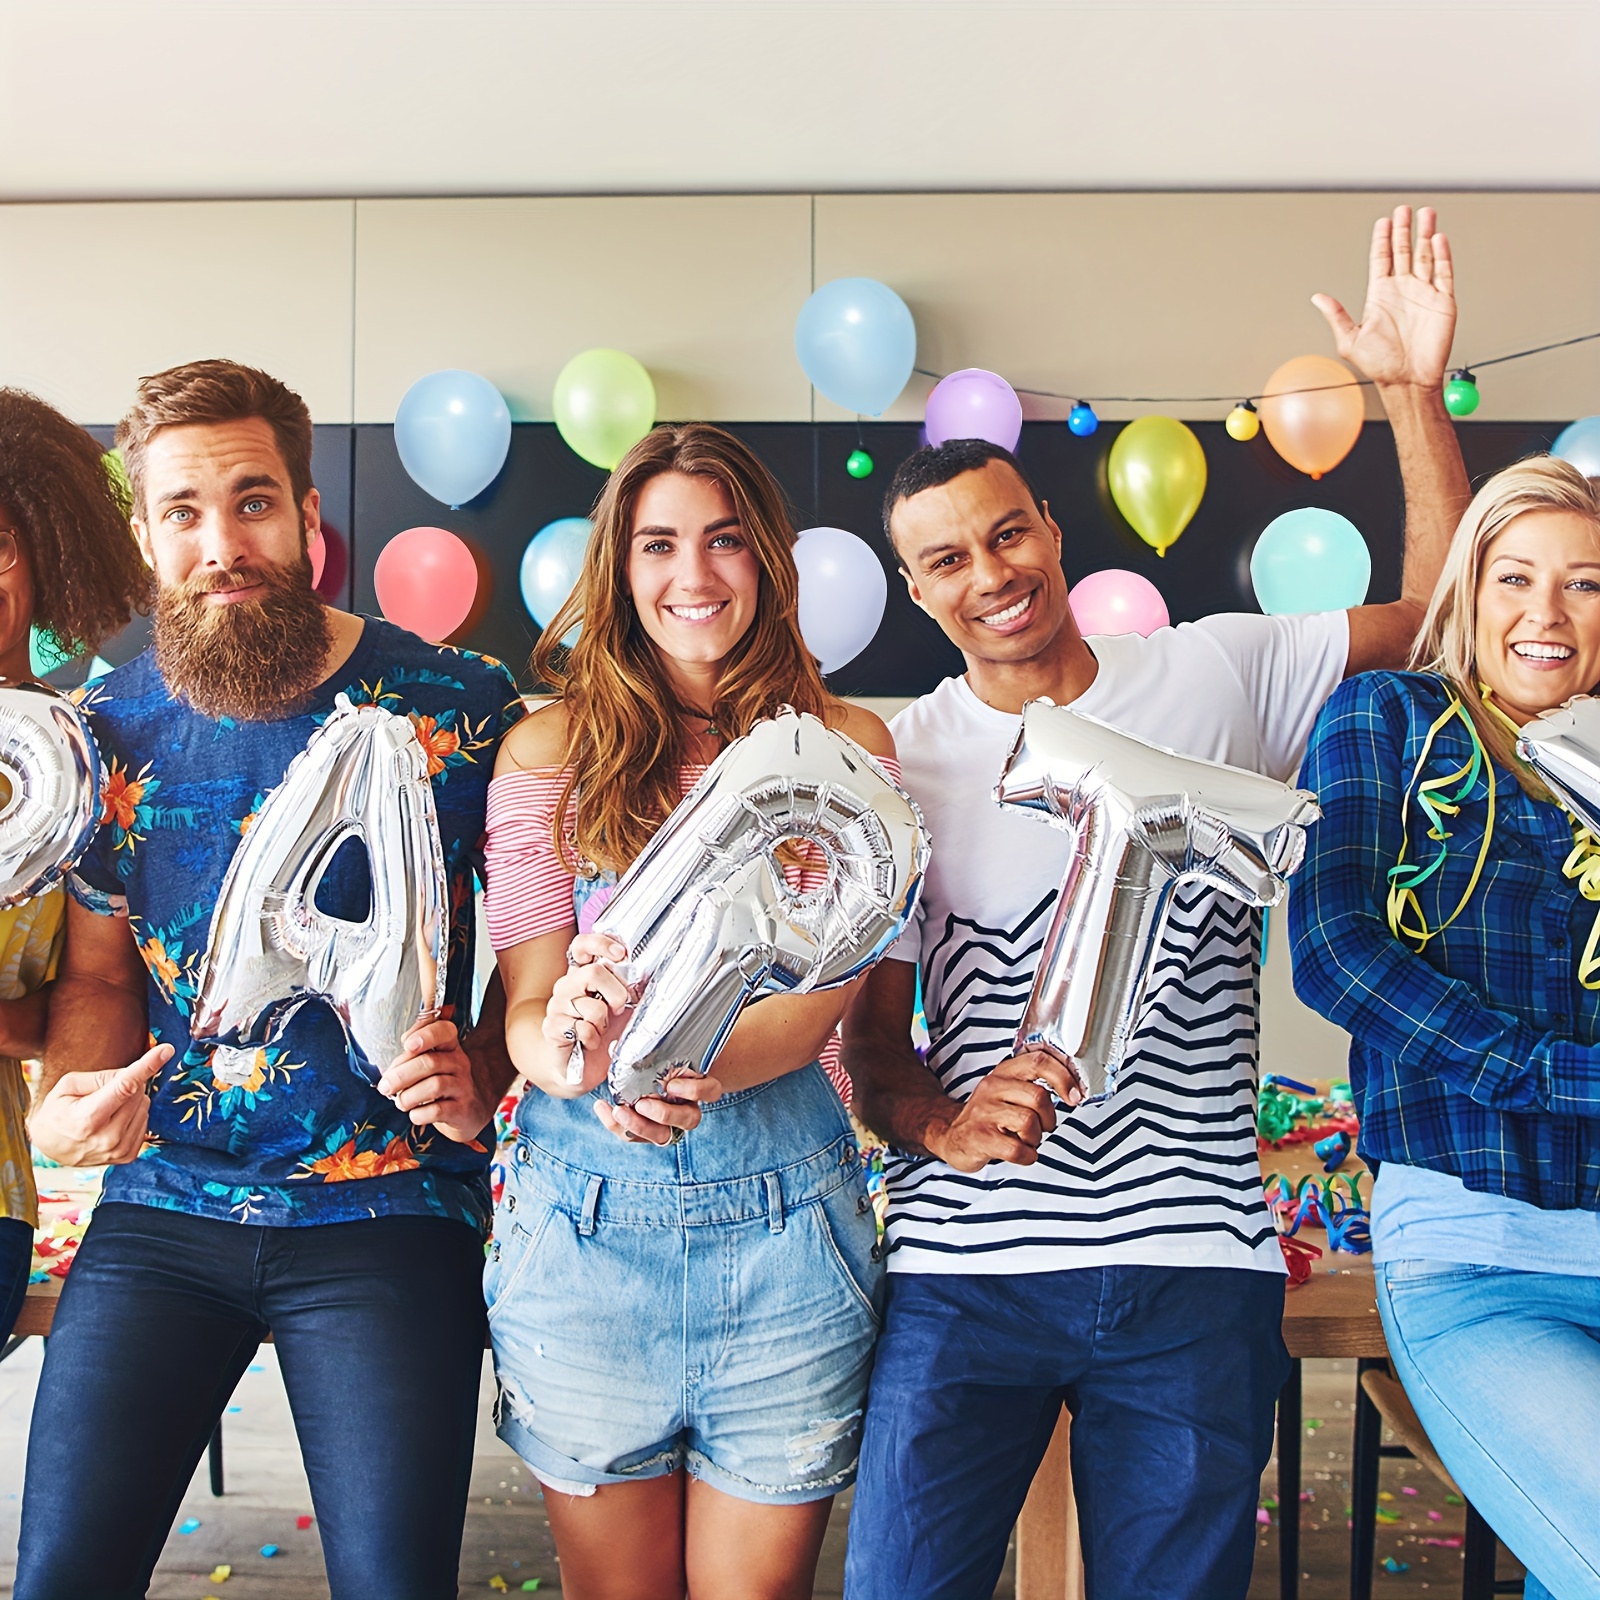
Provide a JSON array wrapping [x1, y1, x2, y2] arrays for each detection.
[[1310, 205, 1456, 392]]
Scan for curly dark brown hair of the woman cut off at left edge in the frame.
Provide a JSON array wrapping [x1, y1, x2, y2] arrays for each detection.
[[0, 389, 150, 656]]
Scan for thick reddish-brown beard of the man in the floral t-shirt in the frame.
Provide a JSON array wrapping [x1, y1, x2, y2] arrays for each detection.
[[154, 554, 333, 722]]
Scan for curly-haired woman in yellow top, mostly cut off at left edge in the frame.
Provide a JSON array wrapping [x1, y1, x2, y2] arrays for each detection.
[[0, 389, 149, 1344]]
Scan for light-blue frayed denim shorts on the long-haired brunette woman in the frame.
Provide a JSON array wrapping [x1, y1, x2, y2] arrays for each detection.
[[485, 1064, 882, 1504]]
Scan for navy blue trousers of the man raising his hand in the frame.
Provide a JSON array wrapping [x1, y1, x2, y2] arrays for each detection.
[[845, 1267, 1290, 1600]]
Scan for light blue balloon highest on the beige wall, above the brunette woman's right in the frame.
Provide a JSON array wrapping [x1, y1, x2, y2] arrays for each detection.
[[795, 278, 917, 416]]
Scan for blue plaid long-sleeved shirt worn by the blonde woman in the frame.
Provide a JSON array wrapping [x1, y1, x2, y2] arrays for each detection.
[[1290, 672, 1600, 1211]]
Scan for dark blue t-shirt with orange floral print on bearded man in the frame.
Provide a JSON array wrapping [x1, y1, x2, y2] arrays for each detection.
[[69, 618, 522, 1227]]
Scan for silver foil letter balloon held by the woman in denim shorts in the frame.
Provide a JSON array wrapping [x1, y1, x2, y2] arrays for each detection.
[[594, 710, 928, 1106]]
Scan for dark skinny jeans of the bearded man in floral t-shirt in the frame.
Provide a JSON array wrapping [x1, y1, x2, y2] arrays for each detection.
[[14, 1203, 483, 1600]]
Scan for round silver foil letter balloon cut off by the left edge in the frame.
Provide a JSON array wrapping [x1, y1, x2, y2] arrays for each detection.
[[0, 678, 101, 906]]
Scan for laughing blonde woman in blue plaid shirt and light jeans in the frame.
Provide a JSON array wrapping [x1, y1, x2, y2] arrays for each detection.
[[1290, 456, 1600, 1600]]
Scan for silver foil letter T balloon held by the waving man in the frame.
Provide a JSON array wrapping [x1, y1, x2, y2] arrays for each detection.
[[995, 699, 1322, 1101]]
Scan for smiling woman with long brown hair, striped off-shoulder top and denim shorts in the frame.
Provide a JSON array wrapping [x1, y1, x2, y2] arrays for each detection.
[[486, 424, 894, 1600]]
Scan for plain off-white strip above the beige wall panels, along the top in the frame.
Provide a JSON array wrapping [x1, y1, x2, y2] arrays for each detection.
[[0, 0, 1600, 200]]
